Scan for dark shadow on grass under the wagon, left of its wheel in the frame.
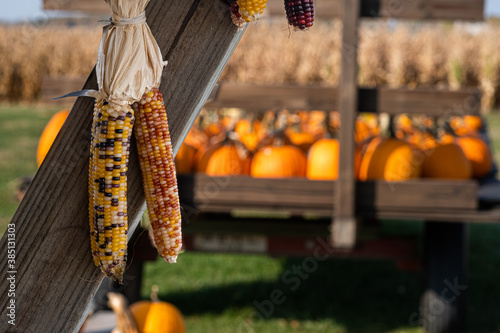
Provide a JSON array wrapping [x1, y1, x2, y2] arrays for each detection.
[[161, 259, 421, 332]]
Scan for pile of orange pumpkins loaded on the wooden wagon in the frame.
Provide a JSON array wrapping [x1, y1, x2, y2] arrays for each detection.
[[176, 110, 493, 181]]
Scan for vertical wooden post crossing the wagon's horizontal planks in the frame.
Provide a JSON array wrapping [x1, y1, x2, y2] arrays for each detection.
[[331, 0, 360, 248]]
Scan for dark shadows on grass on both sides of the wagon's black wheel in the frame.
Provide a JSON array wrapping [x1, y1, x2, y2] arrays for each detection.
[[151, 225, 500, 333]]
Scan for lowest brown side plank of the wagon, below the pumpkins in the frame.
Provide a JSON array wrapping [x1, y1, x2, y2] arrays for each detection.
[[178, 173, 478, 216]]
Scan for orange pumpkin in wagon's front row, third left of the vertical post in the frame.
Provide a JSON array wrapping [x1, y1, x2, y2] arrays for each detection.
[[205, 143, 250, 176]]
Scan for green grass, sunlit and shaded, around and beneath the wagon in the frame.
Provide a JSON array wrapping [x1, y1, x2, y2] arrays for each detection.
[[0, 106, 500, 333]]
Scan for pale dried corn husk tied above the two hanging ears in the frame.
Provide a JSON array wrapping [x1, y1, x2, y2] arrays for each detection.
[[96, 0, 165, 105]]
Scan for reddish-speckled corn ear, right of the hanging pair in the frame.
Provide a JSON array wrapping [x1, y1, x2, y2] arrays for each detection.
[[133, 88, 182, 263]]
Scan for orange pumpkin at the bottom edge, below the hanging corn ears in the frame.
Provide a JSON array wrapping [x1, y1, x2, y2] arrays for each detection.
[[129, 301, 186, 333]]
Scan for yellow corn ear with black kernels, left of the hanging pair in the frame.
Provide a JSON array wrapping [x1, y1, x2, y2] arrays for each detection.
[[89, 100, 134, 282]]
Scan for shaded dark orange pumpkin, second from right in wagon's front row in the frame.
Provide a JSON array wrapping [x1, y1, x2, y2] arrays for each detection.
[[422, 142, 472, 179]]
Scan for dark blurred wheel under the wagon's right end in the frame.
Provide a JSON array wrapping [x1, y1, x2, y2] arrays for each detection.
[[420, 222, 468, 333]]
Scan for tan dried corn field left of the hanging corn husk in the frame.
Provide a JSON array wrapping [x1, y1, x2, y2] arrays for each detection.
[[0, 24, 102, 102]]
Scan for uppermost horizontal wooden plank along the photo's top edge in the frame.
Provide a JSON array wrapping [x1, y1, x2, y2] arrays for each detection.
[[47, 0, 484, 21]]
